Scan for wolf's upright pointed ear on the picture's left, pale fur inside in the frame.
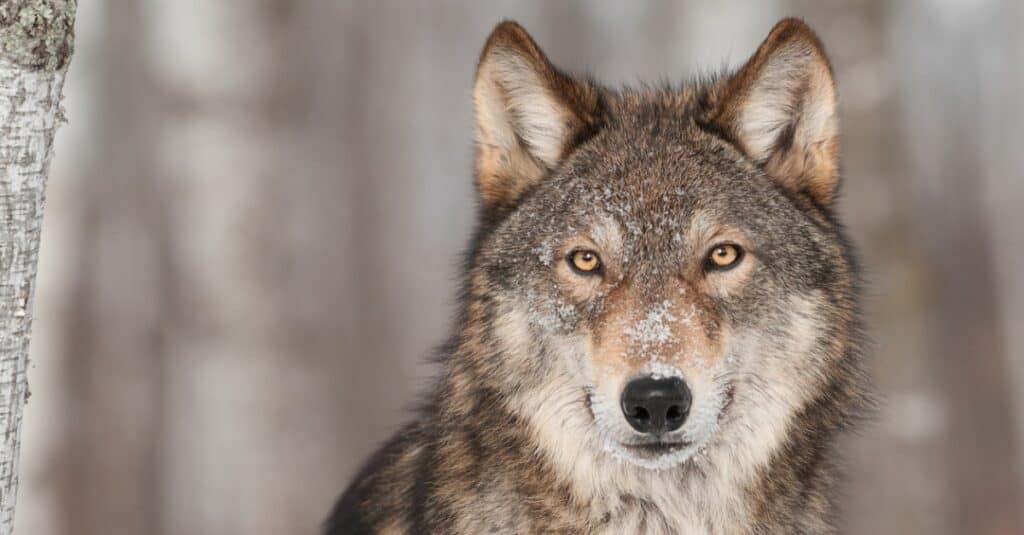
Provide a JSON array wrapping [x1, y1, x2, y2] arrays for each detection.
[[473, 20, 598, 213]]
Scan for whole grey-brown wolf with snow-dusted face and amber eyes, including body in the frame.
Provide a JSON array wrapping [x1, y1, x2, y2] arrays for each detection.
[[325, 19, 868, 535]]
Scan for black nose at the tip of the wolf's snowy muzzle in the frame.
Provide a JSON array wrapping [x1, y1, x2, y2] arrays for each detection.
[[623, 376, 690, 435]]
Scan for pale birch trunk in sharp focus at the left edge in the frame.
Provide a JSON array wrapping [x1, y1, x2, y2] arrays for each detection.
[[0, 0, 76, 535]]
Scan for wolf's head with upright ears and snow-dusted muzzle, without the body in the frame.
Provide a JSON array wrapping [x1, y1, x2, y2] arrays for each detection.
[[455, 19, 858, 469]]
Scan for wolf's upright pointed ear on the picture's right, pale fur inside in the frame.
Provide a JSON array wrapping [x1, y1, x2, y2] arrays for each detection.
[[712, 18, 839, 206]]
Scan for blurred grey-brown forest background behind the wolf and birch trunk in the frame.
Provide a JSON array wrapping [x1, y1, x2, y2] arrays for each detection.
[[9, 0, 1024, 535]]
